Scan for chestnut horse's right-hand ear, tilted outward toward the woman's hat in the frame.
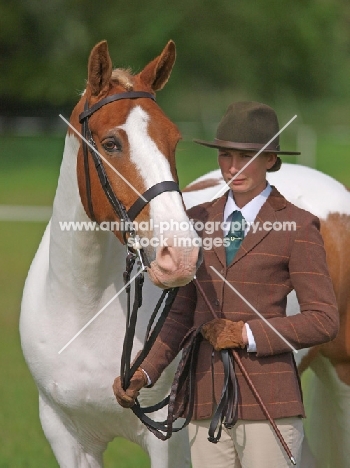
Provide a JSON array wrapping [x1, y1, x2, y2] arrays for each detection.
[[140, 41, 176, 91]]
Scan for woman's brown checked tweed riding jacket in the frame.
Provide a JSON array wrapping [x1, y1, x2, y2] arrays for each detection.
[[142, 187, 339, 420]]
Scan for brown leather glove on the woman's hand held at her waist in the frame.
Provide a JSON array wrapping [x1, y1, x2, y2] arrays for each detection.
[[202, 319, 245, 351]]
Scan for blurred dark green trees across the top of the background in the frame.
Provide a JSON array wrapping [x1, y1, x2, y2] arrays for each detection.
[[0, 0, 350, 117]]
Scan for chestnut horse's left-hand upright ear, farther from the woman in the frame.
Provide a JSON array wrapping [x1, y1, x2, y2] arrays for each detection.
[[88, 41, 112, 96]]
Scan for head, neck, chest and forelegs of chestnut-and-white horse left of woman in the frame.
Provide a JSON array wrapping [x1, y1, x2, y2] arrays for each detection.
[[20, 41, 199, 468]]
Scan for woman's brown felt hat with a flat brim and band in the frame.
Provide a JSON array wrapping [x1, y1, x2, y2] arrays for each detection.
[[193, 101, 300, 154]]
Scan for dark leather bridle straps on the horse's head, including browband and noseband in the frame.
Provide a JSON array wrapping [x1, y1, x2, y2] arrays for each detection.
[[79, 91, 181, 264]]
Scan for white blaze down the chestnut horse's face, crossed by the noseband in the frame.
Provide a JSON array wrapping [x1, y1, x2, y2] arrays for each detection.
[[120, 106, 197, 243]]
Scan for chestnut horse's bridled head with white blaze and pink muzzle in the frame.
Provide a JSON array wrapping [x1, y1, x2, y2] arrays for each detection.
[[71, 41, 200, 288]]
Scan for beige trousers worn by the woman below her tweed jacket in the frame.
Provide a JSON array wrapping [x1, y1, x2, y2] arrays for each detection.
[[189, 418, 304, 468]]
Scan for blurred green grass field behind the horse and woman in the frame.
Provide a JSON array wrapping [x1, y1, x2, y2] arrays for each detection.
[[0, 135, 350, 468]]
